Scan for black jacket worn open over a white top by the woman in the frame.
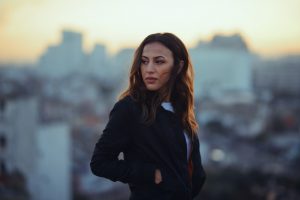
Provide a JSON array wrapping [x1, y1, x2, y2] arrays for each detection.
[[90, 97, 205, 200]]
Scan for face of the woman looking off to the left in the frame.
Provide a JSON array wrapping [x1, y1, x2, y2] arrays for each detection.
[[141, 42, 174, 91]]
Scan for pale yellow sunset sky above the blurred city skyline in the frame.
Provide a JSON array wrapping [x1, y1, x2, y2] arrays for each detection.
[[0, 0, 300, 62]]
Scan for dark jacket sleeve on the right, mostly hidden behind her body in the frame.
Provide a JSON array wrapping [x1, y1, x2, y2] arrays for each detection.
[[192, 136, 206, 198]]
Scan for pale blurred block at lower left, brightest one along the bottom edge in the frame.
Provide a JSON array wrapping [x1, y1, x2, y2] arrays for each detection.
[[32, 123, 72, 200]]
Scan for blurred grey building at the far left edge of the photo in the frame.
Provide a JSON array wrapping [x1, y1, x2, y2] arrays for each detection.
[[0, 96, 38, 196]]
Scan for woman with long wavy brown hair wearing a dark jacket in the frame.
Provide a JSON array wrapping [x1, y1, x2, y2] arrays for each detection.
[[90, 33, 205, 200]]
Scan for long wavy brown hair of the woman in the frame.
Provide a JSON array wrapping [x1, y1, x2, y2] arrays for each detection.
[[120, 33, 198, 138]]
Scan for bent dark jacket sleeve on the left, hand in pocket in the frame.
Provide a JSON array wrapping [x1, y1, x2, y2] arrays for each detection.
[[90, 100, 155, 183]]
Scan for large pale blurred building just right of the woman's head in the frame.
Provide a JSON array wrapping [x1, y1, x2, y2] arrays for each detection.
[[190, 34, 253, 103]]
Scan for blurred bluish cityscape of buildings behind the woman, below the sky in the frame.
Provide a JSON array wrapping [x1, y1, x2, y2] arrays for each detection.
[[0, 30, 300, 200]]
